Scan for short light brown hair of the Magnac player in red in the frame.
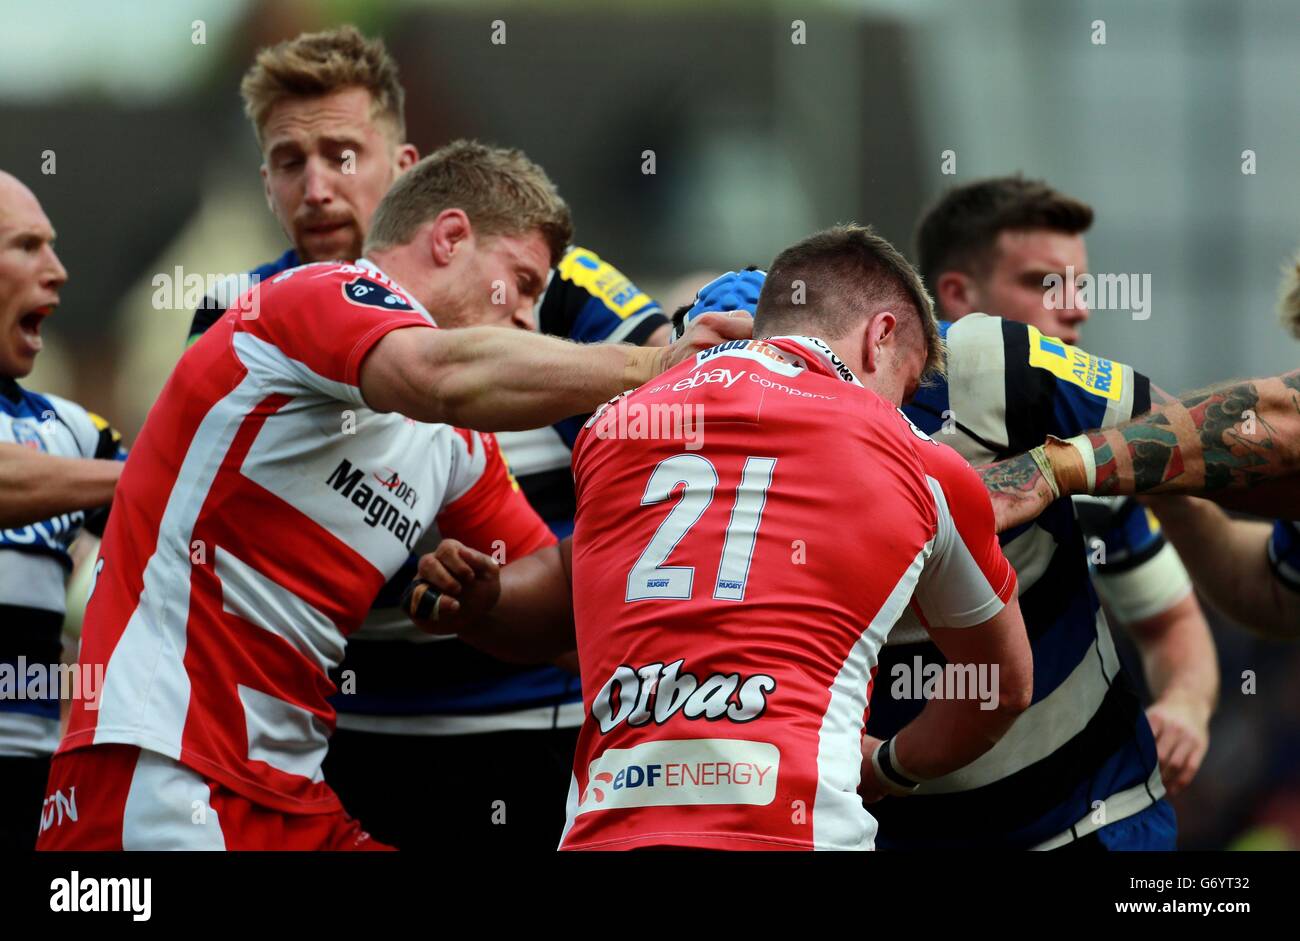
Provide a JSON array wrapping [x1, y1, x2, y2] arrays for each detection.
[[365, 140, 573, 268]]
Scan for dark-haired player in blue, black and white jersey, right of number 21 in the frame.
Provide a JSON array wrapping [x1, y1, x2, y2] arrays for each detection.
[[868, 175, 1218, 850]]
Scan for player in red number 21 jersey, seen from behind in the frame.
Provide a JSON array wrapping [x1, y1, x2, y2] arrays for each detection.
[[412, 226, 1032, 850]]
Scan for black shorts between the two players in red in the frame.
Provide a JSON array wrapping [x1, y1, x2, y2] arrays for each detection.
[[324, 727, 579, 853]]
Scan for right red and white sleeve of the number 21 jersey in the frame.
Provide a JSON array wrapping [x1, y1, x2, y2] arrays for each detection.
[[915, 442, 1015, 628]]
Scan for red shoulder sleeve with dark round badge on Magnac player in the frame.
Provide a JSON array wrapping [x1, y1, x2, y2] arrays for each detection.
[[226, 264, 433, 404]]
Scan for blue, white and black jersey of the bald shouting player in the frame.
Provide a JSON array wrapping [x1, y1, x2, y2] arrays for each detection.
[[0, 377, 126, 755]]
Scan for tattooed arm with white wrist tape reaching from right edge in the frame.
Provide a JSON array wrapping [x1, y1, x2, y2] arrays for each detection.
[[980, 369, 1300, 532]]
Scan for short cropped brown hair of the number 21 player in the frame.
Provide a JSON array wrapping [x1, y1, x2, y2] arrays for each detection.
[[754, 225, 944, 378]]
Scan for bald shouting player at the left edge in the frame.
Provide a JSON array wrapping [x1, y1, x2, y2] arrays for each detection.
[[0, 170, 125, 851]]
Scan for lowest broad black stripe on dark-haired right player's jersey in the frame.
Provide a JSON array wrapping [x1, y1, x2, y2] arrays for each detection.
[[871, 673, 1141, 845]]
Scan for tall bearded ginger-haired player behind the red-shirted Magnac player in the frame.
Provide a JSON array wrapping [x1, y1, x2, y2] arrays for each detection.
[[190, 26, 667, 849]]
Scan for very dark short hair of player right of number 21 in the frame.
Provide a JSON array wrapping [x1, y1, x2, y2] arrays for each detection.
[[917, 174, 1092, 286]]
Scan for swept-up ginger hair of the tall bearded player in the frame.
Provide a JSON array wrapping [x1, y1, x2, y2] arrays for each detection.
[[239, 26, 406, 144]]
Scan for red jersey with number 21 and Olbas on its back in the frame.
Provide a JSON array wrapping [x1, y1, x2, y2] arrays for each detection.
[[560, 337, 1015, 849]]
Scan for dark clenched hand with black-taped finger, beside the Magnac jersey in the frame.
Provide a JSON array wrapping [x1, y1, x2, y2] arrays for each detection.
[[403, 539, 501, 634]]
